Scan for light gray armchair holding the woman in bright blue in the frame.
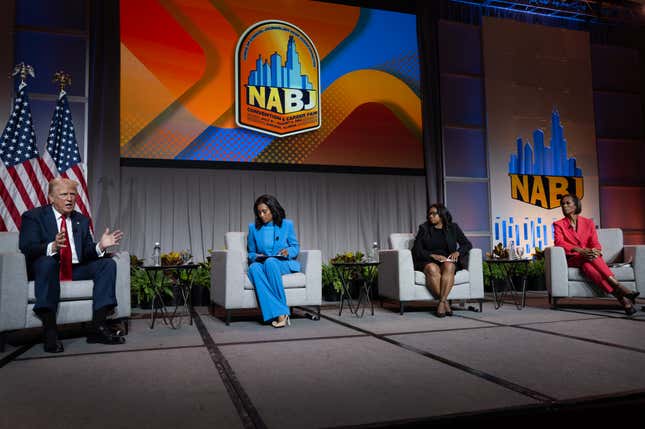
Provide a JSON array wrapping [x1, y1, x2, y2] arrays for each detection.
[[211, 232, 322, 325]]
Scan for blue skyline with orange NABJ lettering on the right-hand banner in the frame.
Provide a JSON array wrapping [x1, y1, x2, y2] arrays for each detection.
[[508, 109, 584, 209]]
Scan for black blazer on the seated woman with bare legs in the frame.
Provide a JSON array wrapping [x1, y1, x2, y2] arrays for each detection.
[[412, 222, 473, 271]]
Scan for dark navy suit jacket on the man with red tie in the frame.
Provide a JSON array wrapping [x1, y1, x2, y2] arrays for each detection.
[[18, 205, 98, 277]]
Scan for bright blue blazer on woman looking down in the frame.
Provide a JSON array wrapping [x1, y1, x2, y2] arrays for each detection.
[[247, 219, 300, 273]]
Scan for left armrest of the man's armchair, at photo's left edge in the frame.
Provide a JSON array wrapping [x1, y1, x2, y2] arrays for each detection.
[[0, 252, 28, 332]]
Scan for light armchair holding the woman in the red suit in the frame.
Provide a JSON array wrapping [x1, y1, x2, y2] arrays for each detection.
[[544, 228, 645, 308]]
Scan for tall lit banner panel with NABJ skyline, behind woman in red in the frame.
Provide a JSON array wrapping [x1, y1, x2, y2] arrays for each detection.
[[482, 18, 600, 254]]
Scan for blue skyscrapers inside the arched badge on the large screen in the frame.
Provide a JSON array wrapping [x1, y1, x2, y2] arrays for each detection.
[[247, 36, 313, 90]]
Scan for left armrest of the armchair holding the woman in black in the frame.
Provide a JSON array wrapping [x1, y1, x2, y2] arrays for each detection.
[[378, 249, 414, 301]]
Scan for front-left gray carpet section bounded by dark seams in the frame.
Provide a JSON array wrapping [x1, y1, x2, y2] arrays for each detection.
[[0, 348, 242, 429]]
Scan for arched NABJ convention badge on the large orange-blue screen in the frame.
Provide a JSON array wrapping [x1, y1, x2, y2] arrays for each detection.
[[235, 20, 321, 137]]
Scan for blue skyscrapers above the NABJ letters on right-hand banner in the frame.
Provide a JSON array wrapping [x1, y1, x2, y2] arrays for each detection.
[[508, 109, 582, 177]]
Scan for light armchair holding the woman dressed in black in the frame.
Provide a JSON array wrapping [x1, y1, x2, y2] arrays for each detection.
[[378, 233, 484, 314]]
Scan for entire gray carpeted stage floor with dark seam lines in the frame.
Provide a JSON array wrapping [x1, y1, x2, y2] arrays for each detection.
[[0, 302, 645, 429]]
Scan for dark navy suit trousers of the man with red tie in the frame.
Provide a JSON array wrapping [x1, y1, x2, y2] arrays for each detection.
[[31, 256, 117, 313]]
